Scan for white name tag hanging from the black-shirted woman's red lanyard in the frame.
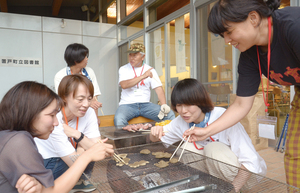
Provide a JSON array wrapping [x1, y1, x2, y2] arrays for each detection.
[[256, 116, 277, 139]]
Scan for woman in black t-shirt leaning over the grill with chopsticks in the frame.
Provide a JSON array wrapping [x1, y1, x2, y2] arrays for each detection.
[[184, 0, 300, 188]]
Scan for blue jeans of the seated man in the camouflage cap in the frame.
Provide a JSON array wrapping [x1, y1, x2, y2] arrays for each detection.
[[114, 103, 175, 126]]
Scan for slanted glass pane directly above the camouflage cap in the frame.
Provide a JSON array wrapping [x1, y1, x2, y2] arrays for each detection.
[[118, 11, 144, 41]]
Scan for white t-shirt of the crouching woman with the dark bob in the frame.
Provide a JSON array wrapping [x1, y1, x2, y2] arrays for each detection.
[[161, 107, 267, 175]]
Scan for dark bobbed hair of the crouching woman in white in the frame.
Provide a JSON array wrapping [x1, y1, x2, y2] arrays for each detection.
[[171, 78, 214, 113]]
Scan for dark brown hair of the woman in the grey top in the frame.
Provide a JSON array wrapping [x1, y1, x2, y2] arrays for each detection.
[[0, 81, 63, 137]]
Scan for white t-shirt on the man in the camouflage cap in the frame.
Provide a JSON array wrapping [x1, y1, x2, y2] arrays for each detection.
[[119, 63, 162, 105]]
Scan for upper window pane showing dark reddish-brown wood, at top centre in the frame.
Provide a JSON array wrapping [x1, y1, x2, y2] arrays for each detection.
[[149, 0, 190, 25]]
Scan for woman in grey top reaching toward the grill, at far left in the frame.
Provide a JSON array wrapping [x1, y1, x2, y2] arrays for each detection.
[[0, 81, 114, 193]]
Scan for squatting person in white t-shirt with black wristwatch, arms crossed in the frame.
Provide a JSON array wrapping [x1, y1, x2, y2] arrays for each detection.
[[35, 74, 107, 192]]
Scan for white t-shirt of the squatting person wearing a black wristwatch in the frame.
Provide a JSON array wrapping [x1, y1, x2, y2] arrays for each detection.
[[34, 108, 100, 159]]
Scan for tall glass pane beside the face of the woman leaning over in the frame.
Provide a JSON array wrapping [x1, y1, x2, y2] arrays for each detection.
[[197, 3, 233, 107]]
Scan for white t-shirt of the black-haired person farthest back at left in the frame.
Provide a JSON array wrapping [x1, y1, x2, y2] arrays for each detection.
[[54, 66, 101, 96]]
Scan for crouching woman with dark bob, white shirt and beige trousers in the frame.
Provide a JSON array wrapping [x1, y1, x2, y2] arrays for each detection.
[[150, 79, 267, 191]]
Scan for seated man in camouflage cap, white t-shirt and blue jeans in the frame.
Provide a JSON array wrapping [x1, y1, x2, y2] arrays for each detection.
[[114, 43, 175, 126]]
